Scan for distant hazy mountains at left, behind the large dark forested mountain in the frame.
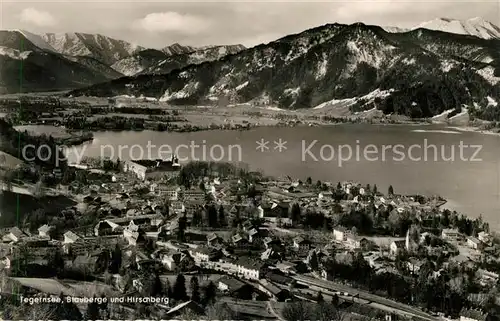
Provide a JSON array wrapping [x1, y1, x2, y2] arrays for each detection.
[[0, 30, 245, 93]]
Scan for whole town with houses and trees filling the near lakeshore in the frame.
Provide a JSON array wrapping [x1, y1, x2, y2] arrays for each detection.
[[0, 142, 500, 321]]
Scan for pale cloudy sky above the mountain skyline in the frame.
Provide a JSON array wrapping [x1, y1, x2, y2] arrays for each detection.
[[0, 0, 500, 48]]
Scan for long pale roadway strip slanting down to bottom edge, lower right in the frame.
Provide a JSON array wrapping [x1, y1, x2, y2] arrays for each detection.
[[293, 275, 439, 321]]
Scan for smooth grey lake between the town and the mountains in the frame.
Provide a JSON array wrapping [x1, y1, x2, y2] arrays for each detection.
[[17, 124, 500, 229]]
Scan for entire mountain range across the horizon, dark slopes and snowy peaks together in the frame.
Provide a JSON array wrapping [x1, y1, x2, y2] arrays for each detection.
[[0, 18, 500, 117]]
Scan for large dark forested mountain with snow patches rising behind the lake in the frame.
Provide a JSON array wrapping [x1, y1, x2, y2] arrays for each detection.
[[70, 23, 500, 117]]
